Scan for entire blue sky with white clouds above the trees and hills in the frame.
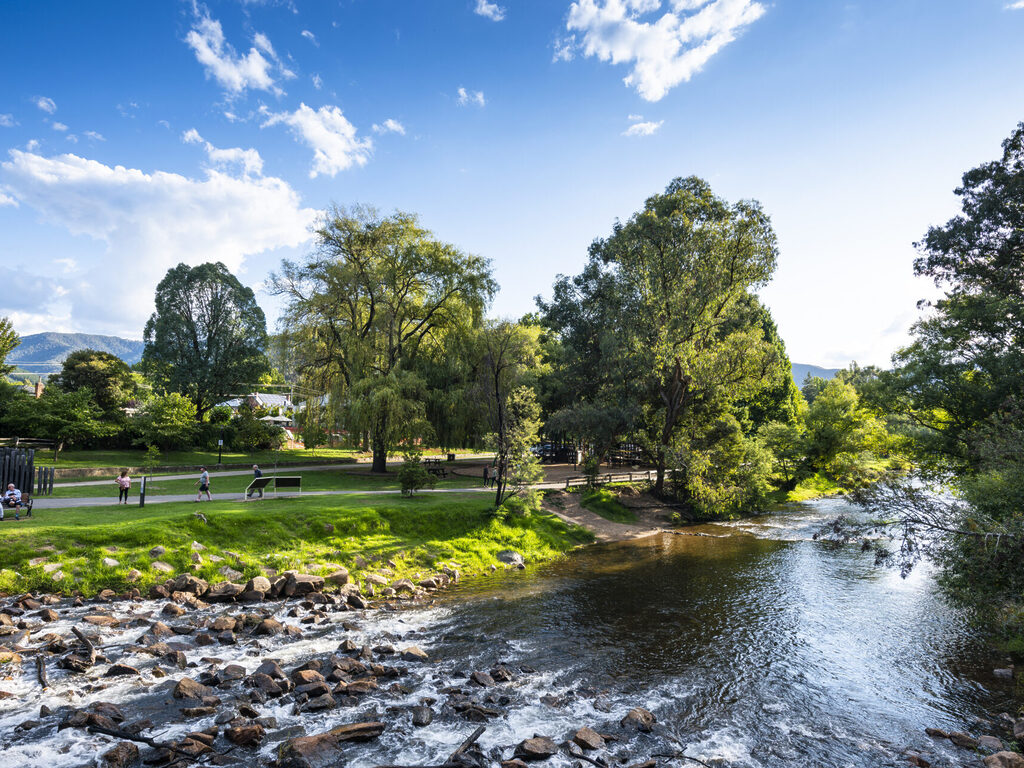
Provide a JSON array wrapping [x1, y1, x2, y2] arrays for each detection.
[[0, 0, 1024, 367]]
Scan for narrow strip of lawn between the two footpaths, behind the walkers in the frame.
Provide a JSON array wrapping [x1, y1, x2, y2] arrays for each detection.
[[51, 467, 480, 504]]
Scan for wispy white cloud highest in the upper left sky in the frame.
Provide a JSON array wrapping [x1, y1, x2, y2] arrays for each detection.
[[185, 6, 295, 95]]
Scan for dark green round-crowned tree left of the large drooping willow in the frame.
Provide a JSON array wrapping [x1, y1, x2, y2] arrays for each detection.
[[142, 262, 268, 421]]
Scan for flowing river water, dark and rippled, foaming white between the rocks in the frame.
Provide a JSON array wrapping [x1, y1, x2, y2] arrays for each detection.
[[0, 500, 1012, 768]]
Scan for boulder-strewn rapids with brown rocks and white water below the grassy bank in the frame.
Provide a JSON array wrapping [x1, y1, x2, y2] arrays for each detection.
[[0, 552, 679, 768]]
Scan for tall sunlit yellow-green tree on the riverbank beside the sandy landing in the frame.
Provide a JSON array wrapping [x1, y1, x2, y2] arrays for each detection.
[[541, 177, 784, 493]]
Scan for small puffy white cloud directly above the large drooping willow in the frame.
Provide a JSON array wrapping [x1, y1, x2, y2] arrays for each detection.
[[262, 103, 374, 178]]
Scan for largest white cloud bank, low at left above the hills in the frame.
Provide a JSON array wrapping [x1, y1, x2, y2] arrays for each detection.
[[0, 150, 318, 337]]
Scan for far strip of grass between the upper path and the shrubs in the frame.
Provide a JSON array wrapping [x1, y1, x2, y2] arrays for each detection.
[[36, 447, 471, 469]]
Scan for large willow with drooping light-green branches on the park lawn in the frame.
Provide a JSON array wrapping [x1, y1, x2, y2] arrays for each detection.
[[271, 207, 497, 472]]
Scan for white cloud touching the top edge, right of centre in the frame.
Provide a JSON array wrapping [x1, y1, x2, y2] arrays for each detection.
[[566, 0, 765, 101]]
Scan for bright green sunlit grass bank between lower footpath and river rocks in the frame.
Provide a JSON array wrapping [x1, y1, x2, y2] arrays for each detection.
[[0, 494, 592, 595]]
